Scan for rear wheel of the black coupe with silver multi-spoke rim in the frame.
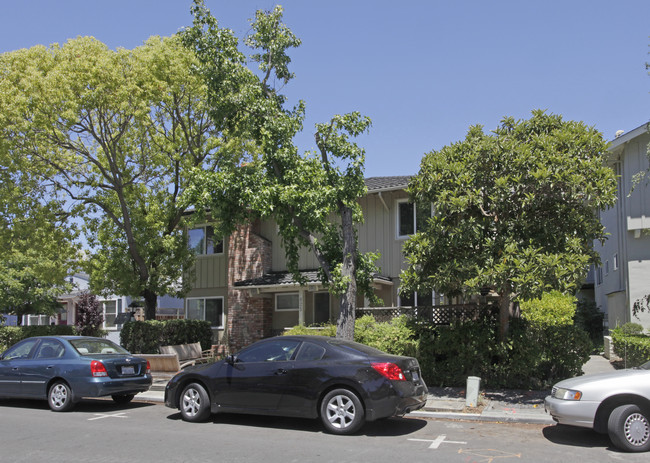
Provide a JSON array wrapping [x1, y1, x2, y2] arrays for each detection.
[[320, 389, 365, 434]]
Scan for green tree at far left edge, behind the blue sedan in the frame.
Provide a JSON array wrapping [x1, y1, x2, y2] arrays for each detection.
[[0, 119, 77, 322]]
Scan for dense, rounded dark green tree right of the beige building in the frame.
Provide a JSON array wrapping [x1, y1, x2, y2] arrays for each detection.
[[402, 111, 616, 336]]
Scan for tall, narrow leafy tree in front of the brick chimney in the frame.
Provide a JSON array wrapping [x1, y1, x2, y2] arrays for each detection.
[[183, 0, 376, 339]]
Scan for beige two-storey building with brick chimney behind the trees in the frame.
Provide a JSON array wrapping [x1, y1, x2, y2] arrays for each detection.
[[185, 176, 440, 345]]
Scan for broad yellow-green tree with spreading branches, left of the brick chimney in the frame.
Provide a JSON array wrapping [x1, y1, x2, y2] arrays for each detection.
[[0, 37, 239, 319]]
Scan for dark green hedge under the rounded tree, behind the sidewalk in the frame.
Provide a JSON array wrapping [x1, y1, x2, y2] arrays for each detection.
[[416, 313, 591, 389]]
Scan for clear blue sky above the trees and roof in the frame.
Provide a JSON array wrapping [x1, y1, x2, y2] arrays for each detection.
[[0, 0, 650, 176]]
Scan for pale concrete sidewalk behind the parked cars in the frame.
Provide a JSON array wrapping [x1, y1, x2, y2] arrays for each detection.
[[134, 355, 614, 424]]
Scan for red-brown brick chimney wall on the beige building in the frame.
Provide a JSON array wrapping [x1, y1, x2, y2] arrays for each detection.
[[227, 222, 273, 352]]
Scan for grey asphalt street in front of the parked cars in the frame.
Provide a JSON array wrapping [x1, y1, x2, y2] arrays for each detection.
[[0, 400, 648, 463]]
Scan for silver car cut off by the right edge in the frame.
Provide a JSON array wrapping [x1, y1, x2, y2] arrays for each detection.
[[544, 362, 650, 452]]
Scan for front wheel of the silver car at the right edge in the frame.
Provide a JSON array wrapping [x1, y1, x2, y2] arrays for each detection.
[[607, 404, 650, 452]]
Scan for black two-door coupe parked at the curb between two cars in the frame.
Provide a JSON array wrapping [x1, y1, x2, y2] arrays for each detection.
[[165, 336, 427, 434]]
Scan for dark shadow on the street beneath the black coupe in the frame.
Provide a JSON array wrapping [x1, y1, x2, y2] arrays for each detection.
[[167, 413, 427, 438]]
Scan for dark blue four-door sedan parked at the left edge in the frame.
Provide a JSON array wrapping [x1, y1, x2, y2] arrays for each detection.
[[0, 336, 151, 412]]
